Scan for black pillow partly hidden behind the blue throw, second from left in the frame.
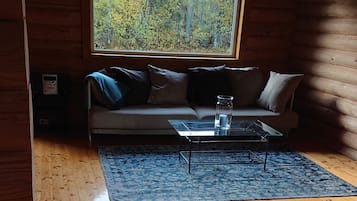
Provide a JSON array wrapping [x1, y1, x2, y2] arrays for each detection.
[[105, 66, 151, 105]]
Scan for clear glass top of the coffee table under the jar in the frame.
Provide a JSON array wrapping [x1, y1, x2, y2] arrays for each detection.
[[169, 120, 283, 138]]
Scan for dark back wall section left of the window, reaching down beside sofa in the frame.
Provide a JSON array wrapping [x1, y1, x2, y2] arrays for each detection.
[[26, 0, 86, 131]]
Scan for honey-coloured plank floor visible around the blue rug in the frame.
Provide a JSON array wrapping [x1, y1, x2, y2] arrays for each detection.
[[34, 134, 357, 201]]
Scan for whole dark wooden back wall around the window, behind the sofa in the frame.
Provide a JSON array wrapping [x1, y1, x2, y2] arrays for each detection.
[[26, 0, 295, 131]]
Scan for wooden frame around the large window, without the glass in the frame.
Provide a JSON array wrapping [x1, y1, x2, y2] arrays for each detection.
[[86, 0, 245, 61]]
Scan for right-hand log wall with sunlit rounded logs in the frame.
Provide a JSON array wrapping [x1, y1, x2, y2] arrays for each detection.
[[292, 0, 357, 159]]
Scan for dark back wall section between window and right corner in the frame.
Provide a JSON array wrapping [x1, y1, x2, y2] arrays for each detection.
[[236, 0, 295, 68]]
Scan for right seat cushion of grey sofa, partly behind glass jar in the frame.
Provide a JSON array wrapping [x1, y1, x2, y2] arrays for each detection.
[[194, 106, 298, 132]]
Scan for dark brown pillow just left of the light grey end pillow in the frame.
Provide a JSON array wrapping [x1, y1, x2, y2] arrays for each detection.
[[226, 67, 265, 106]]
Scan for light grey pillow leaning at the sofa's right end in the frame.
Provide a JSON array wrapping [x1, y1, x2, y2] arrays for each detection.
[[257, 71, 303, 113]]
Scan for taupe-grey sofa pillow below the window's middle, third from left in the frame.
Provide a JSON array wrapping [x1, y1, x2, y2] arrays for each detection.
[[148, 65, 188, 105]]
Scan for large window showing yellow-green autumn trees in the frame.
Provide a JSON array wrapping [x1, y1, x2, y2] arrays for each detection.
[[91, 0, 241, 58]]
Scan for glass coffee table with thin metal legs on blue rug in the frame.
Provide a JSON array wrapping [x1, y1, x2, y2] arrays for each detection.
[[169, 120, 283, 173]]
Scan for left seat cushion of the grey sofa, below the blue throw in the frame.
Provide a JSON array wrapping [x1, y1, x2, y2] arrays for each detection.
[[89, 104, 197, 130]]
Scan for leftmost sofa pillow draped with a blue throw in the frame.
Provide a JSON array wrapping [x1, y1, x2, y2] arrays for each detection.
[[86, 72, 128, 109]]
